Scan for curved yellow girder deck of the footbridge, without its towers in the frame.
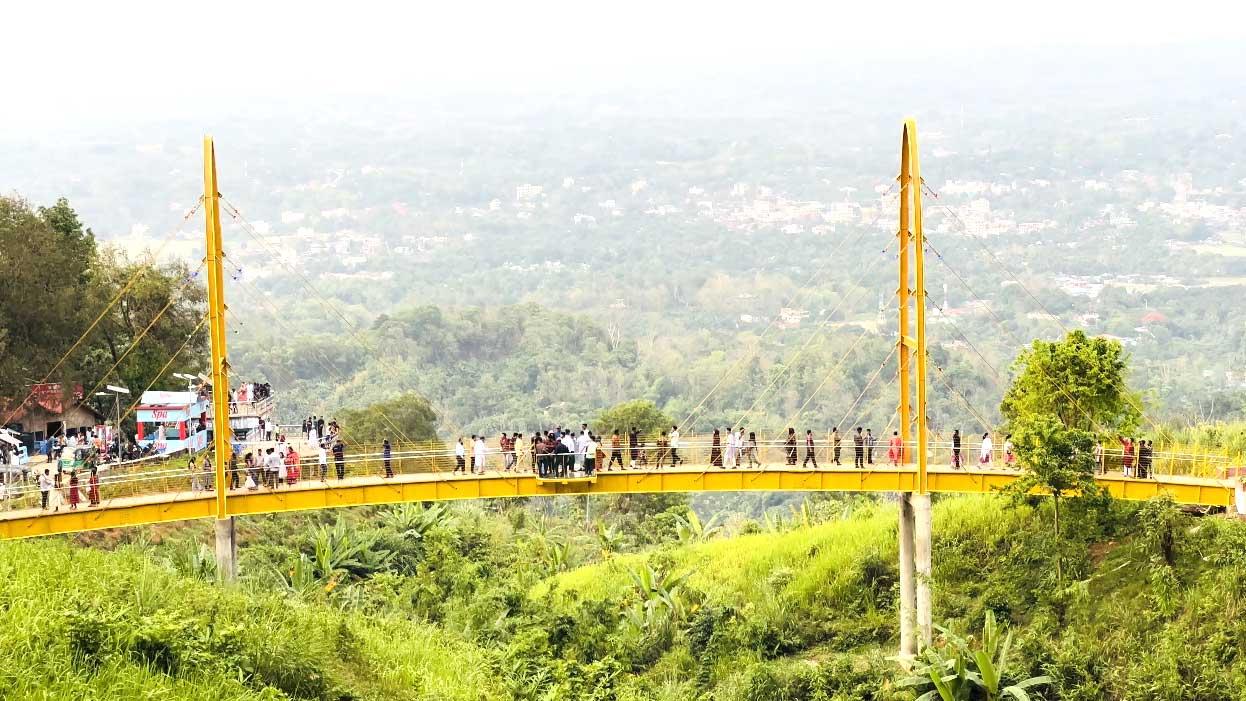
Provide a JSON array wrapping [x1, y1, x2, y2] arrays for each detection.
[[0, 466, 1234, 539]]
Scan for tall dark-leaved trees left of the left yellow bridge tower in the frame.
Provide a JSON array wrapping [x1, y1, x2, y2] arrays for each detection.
[[0, 197, 207, 405]]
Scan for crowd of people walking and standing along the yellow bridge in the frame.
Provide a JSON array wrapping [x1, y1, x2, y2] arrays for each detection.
[[0, 416, 1176, 512]]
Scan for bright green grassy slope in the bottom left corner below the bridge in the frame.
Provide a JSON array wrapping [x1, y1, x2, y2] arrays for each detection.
[[0, 540, 500, 700]]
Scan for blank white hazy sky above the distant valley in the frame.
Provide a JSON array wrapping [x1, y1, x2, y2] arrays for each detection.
[[9, 0, 1246, 105]]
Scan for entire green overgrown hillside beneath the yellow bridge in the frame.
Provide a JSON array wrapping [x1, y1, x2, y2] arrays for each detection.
[[0, 497, 1246, 701]]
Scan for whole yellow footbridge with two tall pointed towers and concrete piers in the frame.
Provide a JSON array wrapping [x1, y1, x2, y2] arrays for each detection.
[[0, 121, 1240, 655]]
